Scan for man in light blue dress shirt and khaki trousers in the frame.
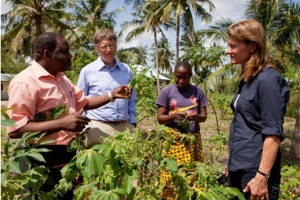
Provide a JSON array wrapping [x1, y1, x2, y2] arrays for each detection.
[[77, 29, 137, 146]]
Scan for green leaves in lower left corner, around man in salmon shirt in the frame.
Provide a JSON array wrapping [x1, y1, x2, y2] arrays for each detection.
[[1, 106, 67, 199]]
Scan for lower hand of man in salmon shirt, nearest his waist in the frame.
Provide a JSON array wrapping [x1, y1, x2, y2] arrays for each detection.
[[58, 110, 90, 132]]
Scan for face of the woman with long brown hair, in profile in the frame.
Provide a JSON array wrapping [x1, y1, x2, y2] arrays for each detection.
[[226, 36, 255, 66]]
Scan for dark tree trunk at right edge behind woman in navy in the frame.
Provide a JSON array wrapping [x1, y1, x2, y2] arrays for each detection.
[[291, 81, 300, 164]]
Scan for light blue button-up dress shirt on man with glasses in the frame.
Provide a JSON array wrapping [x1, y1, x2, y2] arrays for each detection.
[[77, 57, 137, 123]]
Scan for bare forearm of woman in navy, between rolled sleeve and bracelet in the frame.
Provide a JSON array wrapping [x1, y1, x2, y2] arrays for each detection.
[[259, 136, 280, 174]]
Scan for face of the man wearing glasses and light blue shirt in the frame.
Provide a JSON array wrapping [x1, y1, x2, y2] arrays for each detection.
[[96, 39, 117, 63]]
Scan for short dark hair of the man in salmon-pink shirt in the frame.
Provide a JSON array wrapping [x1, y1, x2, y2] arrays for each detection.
[[34, 32, 63, 60]]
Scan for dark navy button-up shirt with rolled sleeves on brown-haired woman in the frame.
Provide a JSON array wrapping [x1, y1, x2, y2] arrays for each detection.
[[227, 67, 290, 171]]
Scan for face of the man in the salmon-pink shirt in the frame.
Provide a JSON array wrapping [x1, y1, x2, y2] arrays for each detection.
[[50, 38, 72, 72]]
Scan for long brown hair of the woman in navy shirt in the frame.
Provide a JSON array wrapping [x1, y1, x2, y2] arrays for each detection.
[[227, 19, 280, 82]]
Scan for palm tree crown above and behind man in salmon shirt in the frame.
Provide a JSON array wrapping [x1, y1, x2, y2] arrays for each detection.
[[1, 0, 72, 58]]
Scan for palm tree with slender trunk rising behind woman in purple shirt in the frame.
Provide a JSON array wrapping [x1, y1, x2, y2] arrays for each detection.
[[155, 0, 215, 62]]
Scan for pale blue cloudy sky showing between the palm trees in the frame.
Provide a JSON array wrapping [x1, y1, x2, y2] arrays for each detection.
[[1, 0, 300, 61]]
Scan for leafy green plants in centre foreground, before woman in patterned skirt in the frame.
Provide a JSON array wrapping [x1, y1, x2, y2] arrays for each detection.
[[55, 127, 243, 200]]
